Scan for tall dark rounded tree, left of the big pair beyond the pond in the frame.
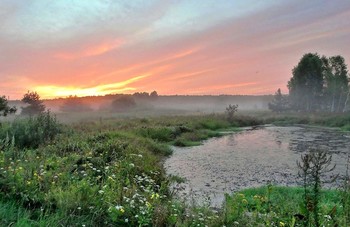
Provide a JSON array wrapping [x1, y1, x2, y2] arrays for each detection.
[[288, 53, 324, 112]]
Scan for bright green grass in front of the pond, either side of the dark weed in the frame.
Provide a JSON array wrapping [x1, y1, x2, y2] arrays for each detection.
[[223, 185, 345, 226]]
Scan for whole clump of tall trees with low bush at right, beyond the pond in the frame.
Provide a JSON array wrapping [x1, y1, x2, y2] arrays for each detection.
[[269, 53, 350, 113]]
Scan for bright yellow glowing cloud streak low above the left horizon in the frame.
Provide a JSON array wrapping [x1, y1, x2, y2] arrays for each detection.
[[34, 75, 149, 98]]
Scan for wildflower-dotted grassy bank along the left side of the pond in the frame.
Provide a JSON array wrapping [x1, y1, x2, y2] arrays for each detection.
[[0, 113, 261, 226]]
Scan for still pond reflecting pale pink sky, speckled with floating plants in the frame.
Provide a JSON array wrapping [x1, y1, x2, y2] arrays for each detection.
[[164, 126, 350, 207]]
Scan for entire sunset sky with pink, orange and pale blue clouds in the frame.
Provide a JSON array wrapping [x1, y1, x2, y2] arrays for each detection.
[[0, 0, 350, 99]]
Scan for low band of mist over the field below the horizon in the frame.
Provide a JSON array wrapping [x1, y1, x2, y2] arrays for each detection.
[[10, 95, 273, 113]]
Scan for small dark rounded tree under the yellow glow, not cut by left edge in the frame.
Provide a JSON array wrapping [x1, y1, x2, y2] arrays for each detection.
[[21, 91, 46, 115]]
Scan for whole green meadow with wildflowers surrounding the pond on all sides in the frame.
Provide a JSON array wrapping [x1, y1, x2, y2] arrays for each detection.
[[0, 109, 350, 226]]
